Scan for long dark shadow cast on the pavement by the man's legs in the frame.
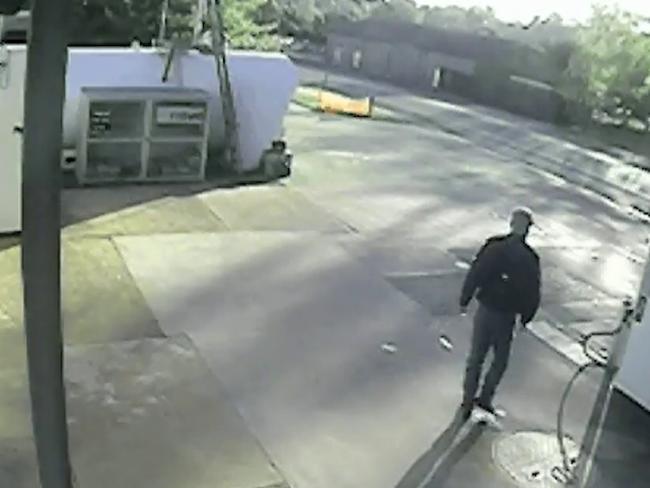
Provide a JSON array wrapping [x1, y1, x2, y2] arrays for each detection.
[[395, 410, 483, 488]]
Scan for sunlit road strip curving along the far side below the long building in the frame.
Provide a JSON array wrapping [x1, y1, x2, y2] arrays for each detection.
[[301, 66, 650, 225]]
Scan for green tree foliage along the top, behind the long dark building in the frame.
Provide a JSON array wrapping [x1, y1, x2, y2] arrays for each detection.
[[57, 0, 650, 127]]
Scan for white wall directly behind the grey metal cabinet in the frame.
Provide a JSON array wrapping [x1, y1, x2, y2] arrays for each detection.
[[0, 46, 298, 171]]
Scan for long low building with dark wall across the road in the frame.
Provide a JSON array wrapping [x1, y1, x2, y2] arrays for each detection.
[[326, 19, 563, 122]]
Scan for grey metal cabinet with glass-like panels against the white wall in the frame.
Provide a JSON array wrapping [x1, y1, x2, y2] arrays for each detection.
[[77, 87, 210, 185]]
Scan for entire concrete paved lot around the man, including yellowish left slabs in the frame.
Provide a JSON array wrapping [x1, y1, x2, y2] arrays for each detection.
[[0, 86, 650, 488]]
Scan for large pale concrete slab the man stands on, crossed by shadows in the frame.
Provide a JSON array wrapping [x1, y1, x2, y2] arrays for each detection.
[[112, 231, 608, 488]]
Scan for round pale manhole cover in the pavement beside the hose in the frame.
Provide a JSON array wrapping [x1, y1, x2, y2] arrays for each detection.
[[492, 432, 580, 488]]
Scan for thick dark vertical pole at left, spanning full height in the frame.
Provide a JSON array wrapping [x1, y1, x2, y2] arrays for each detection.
[[22, 0, 72, 488]]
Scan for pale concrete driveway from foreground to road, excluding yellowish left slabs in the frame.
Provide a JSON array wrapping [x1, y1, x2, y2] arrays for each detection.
[[110, 109, 645, 488]]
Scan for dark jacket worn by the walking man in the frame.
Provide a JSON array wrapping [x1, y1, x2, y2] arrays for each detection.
[[460, 234, 541, 325]]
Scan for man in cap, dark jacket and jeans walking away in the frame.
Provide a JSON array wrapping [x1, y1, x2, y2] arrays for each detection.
[[460, 208, 541, 419]]
